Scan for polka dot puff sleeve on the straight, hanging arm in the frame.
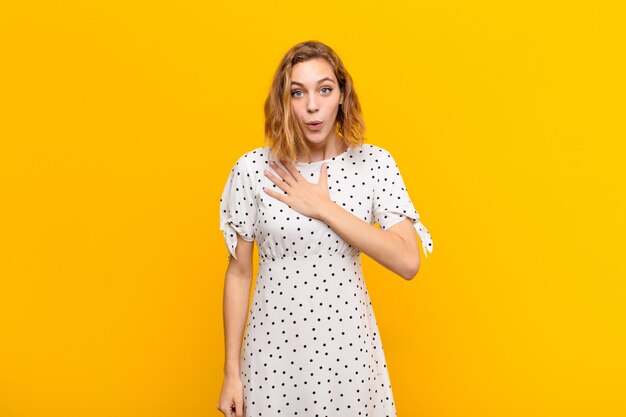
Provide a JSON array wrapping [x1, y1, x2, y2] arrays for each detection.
[[220, 155, 257, 259]]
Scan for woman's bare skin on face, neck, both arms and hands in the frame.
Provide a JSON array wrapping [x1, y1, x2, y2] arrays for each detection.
[[217, 59, 420, 417]]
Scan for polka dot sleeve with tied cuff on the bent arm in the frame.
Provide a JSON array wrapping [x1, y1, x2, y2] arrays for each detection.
[[373, 148, 433, 257]]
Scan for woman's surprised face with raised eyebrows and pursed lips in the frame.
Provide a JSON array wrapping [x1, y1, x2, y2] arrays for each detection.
[[291, 58, 343, 145]]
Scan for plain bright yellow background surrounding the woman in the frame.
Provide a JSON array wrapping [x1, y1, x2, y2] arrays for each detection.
[[0, 0, 626, 417]]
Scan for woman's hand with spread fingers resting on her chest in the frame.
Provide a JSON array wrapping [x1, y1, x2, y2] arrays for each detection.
[[263, 160, 332, 219]]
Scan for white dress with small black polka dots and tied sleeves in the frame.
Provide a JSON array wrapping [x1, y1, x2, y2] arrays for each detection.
[[220, 144, 433, 417]]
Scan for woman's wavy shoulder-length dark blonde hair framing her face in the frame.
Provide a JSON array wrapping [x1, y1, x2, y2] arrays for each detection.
[[264, 41, 365, 162]]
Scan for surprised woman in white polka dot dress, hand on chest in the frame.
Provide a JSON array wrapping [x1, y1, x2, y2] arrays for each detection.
[[218, 41, 433, 417]]
